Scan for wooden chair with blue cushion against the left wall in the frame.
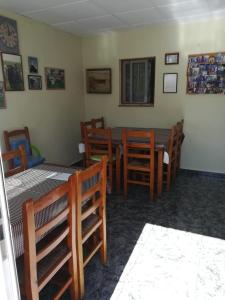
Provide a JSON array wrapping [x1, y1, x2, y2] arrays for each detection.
[[3, 127, 45, 169]]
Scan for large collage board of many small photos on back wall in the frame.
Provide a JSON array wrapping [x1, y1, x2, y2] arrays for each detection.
[[187, 52, 225, 94]]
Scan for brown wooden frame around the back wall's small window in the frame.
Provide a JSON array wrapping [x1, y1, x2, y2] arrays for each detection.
[[119, 56, 156, 107]]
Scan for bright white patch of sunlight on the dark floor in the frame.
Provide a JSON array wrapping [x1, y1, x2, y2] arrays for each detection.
[[111, 224, 225, 300]]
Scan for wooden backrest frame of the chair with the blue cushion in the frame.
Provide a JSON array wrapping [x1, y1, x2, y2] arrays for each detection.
[[3, 127, 32, 155]]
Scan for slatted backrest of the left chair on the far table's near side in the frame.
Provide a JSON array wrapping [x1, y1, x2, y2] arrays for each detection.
[[84, 128, 112, 162]]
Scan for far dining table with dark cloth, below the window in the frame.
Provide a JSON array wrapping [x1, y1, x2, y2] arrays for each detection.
[[112, 127, 170, 196]]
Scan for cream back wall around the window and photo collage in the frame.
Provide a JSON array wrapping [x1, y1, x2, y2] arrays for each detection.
[[82, 19, 225, 173]]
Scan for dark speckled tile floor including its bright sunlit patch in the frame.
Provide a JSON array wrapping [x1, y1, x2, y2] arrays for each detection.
[[43, 172, 225, 300]]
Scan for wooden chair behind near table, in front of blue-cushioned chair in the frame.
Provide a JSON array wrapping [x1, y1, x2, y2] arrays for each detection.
[[2, 145, 27, 177]]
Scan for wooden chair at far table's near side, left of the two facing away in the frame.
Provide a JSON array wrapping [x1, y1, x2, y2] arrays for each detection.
[[84, 128, 120, 191]]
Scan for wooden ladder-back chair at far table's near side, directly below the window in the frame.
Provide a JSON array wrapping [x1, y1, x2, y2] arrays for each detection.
[[122, 129, 155, 199]]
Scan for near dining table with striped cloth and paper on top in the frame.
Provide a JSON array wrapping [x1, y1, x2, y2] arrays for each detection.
[[5, 164, 77, 258]]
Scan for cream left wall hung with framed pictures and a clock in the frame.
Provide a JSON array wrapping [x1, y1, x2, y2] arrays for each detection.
[[0, 10, 84, 164]]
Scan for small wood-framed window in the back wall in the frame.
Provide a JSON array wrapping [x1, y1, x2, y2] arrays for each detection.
[[120, 57, 155, 106]]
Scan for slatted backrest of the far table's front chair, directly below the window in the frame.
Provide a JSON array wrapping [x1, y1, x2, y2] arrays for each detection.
[[122, 128, 155, 173]]
